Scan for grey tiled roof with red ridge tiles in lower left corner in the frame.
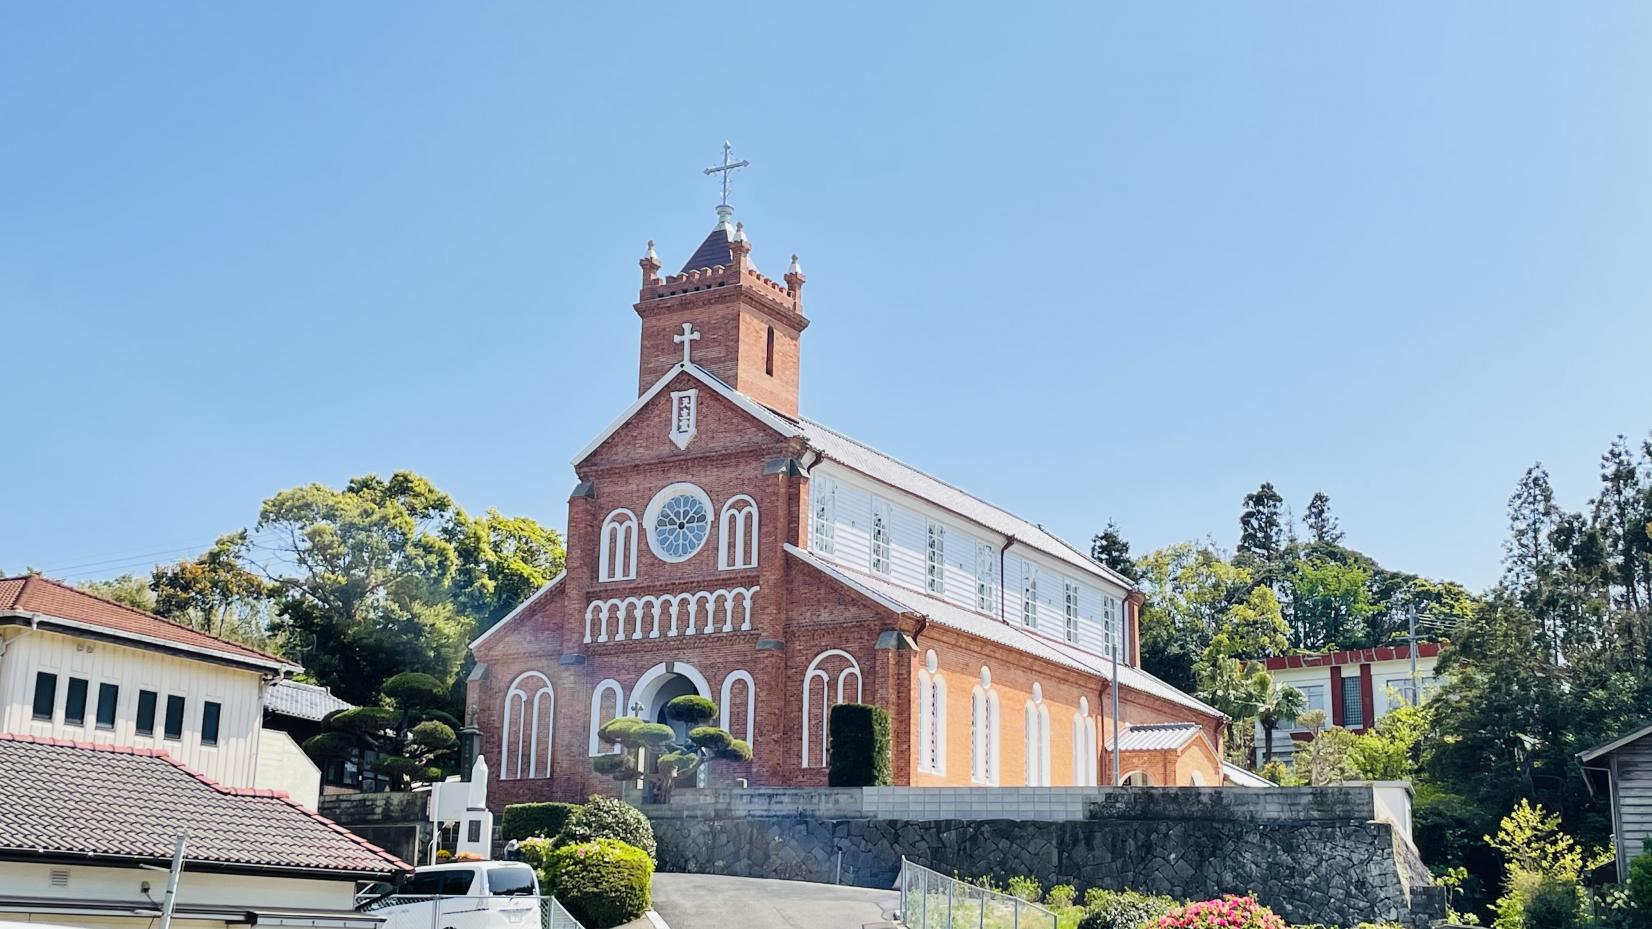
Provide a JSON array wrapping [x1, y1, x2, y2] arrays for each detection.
[[0, 734, 408, 878]]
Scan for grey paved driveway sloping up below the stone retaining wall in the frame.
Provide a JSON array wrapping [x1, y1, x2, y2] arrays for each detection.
[[654, 874, 900, 929]]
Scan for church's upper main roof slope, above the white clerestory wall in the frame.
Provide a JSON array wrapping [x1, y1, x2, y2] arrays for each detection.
[[798, 420, 1135, 590]]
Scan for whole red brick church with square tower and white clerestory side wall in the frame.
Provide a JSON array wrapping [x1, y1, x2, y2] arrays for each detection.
[[469, 181, 1222, 803]]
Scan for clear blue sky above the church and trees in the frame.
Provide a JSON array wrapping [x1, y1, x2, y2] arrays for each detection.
[[0, 2, 1652, 587]]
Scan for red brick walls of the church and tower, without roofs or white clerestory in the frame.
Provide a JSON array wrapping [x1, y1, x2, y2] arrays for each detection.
[[469, 214, 1221, 807]]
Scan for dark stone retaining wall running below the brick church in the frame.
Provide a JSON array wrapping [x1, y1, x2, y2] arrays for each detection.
[[646, 788, 1446, 927]]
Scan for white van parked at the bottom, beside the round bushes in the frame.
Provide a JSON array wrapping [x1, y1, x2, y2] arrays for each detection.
[[360, 861, 540, 929]]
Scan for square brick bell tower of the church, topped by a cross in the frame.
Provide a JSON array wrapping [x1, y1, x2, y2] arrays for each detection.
[[636, 142, 809, 418]]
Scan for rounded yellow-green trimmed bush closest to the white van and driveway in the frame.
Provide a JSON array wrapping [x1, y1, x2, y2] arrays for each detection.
[[540, 838, 654, 929]]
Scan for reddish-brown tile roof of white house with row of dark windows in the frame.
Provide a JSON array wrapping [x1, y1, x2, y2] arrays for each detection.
[[0, 574, 301, 671]]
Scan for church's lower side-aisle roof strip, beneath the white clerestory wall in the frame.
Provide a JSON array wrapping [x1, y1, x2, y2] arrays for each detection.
[[786, 542, 1226, 719]]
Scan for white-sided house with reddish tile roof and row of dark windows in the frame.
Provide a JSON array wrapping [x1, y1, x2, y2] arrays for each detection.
[[0, 575, 320, 796]]
